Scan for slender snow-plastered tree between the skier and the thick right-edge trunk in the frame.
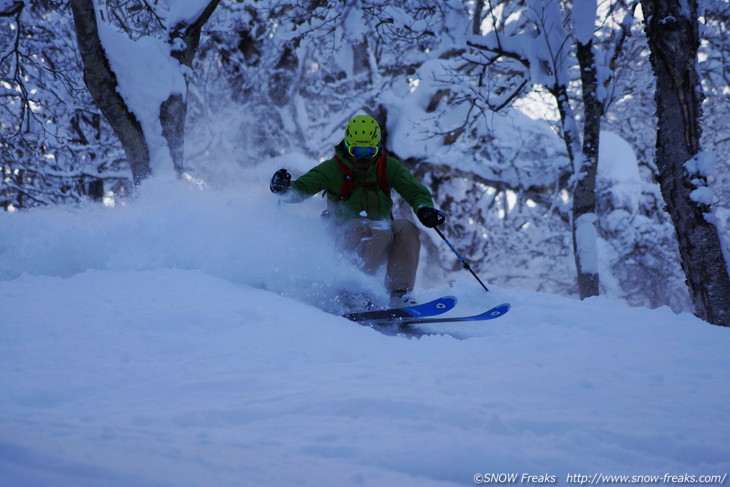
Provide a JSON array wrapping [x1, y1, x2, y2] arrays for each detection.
[[467, 0, 636, 299]]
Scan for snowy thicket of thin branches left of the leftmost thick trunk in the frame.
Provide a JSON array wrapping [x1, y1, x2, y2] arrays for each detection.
[[0, 0, 128, 210]]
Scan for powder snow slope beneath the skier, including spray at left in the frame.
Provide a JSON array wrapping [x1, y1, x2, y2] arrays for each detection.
[[0, 175, 730, 487]]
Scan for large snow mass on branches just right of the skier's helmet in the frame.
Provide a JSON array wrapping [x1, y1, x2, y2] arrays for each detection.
[[381, 60, 565, 191]]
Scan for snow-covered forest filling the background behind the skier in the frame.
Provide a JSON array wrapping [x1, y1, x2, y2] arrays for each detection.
[[0, 0, 730, 324]]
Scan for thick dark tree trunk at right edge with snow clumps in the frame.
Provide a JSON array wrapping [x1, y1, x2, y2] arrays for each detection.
[[641, 0, 730, 326]]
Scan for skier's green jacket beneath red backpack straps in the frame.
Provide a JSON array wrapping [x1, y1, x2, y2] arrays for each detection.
[[288, 143, 433, 220]]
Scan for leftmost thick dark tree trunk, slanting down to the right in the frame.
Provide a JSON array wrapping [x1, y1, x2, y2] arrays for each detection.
[[71, 0, 150, 184]]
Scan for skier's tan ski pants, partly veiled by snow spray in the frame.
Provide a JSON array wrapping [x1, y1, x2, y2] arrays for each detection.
[[337, 218, 421, 292]]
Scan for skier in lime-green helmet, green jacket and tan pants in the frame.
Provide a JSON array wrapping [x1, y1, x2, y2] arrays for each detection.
[[269, 115, 445, 307]]
